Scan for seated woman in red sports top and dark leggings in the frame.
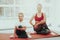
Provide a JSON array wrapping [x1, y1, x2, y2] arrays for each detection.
[[30, 4, 50, 34]]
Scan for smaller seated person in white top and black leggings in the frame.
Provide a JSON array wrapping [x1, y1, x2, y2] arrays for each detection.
[[14, 13, 28, 38]]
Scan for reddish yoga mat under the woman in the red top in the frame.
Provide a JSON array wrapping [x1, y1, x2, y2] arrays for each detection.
[[31, 31, 60, 38]]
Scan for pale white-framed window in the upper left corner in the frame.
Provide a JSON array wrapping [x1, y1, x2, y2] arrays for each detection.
[[0, 0, 15, 18]]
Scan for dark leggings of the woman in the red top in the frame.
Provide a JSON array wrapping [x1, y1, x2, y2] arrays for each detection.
[[34, 23, 50, 34]]
